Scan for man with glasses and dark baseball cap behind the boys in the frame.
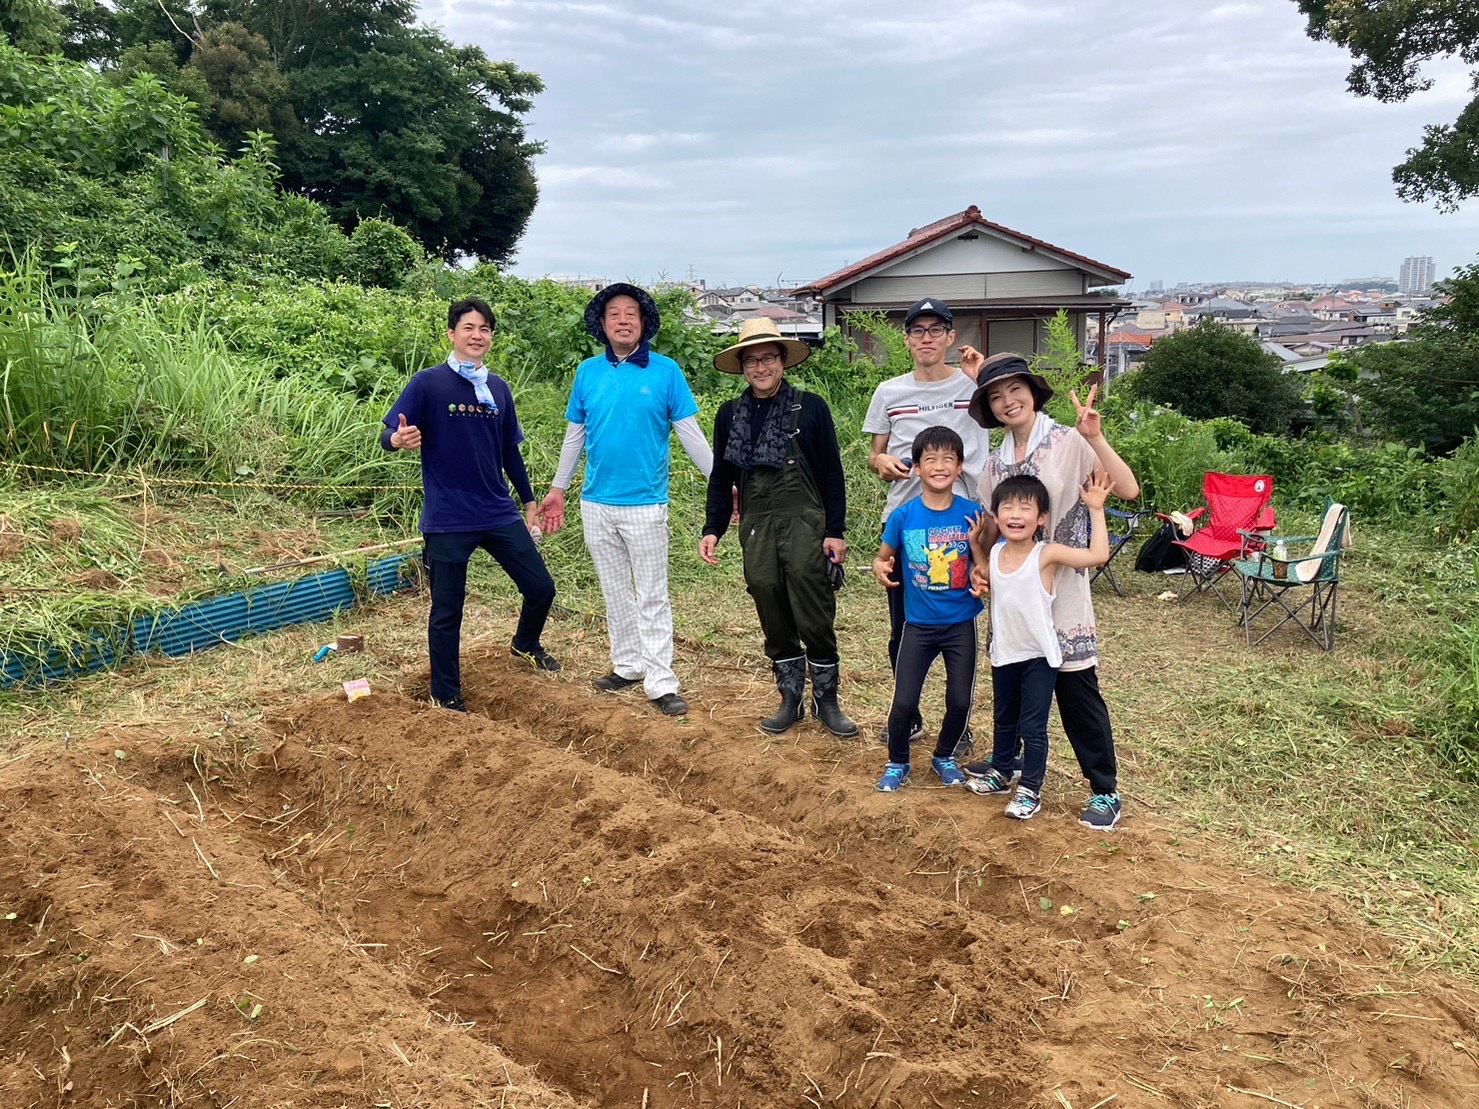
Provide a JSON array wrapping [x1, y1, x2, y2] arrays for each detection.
[[862, 297, 989, 754]]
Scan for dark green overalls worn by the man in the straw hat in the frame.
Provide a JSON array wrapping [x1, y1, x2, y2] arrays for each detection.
[[740, 396, 837, 662]]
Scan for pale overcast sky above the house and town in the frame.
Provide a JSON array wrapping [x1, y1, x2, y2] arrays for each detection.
[[422, 0, 1479, 288]]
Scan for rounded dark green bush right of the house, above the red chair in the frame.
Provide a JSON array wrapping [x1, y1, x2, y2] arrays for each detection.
[[1123, 318, 1299, 435]]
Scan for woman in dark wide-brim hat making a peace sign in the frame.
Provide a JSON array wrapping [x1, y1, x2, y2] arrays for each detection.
[[966, 353, 1140, 831]]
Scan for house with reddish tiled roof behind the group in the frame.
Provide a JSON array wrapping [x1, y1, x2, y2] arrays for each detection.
[[796, 204, 1130, 366]]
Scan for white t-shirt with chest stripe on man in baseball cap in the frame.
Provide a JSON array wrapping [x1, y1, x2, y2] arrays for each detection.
[[862, 370, 991, 519]]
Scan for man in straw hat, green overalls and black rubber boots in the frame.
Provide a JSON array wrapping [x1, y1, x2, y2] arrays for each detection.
[[698, 319, 858, 739]]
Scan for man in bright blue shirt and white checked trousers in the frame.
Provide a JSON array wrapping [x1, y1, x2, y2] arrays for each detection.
[[540, 282, 713, 716]]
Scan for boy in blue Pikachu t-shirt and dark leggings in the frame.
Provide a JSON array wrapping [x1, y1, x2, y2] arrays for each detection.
[[873, 426, 985, 793]]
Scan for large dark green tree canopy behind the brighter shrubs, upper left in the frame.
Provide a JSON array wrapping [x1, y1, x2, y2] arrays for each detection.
[[46, 0, 544, 263]]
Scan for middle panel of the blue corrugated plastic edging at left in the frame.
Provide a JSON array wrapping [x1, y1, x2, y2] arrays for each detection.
[[133, 569, 355, 657]]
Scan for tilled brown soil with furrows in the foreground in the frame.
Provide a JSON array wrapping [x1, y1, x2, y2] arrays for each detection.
[[0, 657, 1479, 1109]]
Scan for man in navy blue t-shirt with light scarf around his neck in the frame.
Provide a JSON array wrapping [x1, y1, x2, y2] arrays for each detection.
[[380, 297, 559, 713]]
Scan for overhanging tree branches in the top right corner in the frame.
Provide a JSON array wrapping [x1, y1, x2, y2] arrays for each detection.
[[1296, 0, 1479, 211]]
